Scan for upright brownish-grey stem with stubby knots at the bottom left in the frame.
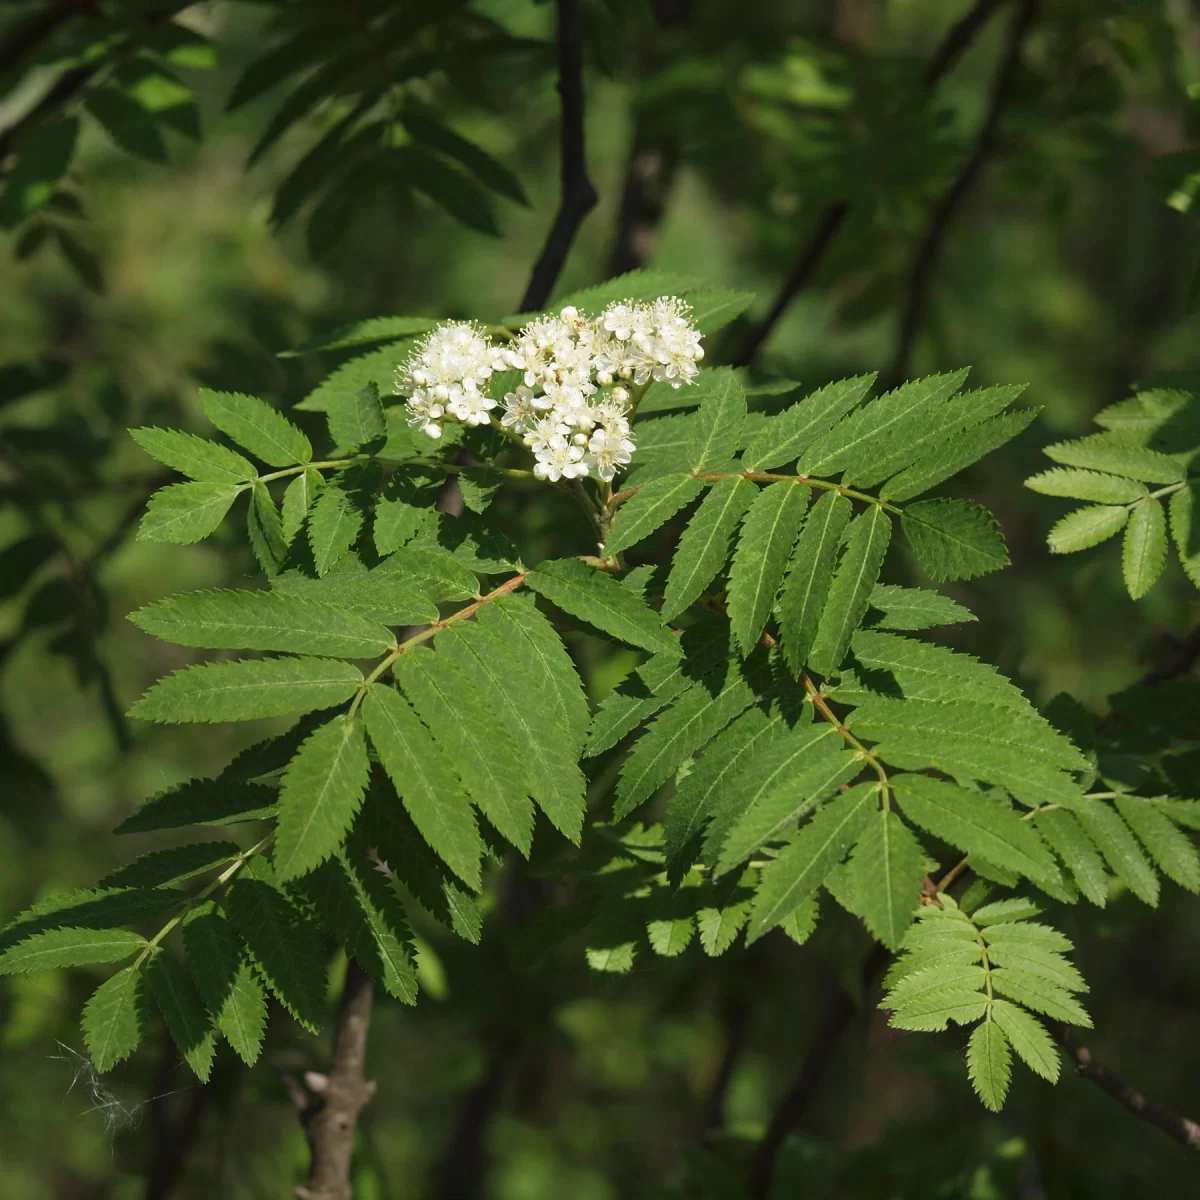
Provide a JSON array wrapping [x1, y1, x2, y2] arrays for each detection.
[[296, 959, 376, 1200]]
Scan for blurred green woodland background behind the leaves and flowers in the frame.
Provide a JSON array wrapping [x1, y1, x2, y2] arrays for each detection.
[[0, 0, 1200, 1200]]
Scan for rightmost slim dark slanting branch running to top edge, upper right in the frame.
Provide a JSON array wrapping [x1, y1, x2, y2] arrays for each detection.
[[887, 0, 1038, 386]]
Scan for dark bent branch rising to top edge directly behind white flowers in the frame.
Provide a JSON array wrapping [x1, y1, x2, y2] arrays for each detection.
[[521, 0, 596, 312]]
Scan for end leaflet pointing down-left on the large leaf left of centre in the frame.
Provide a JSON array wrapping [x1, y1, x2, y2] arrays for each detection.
[[275, 706, 373, 882]]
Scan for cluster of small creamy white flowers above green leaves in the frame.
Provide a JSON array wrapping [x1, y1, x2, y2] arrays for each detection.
[[396, 296, 704, 482]]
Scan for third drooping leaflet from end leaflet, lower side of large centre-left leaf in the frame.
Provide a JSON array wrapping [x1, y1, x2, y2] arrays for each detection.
[[438, 619, 590, 845]]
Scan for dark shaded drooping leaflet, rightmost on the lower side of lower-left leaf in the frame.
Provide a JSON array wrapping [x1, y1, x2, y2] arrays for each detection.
[[225, 875, 326, 1033]]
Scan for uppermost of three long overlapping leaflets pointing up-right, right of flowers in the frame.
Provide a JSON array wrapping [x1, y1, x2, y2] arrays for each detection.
[[796, 370, 967, 486]]
